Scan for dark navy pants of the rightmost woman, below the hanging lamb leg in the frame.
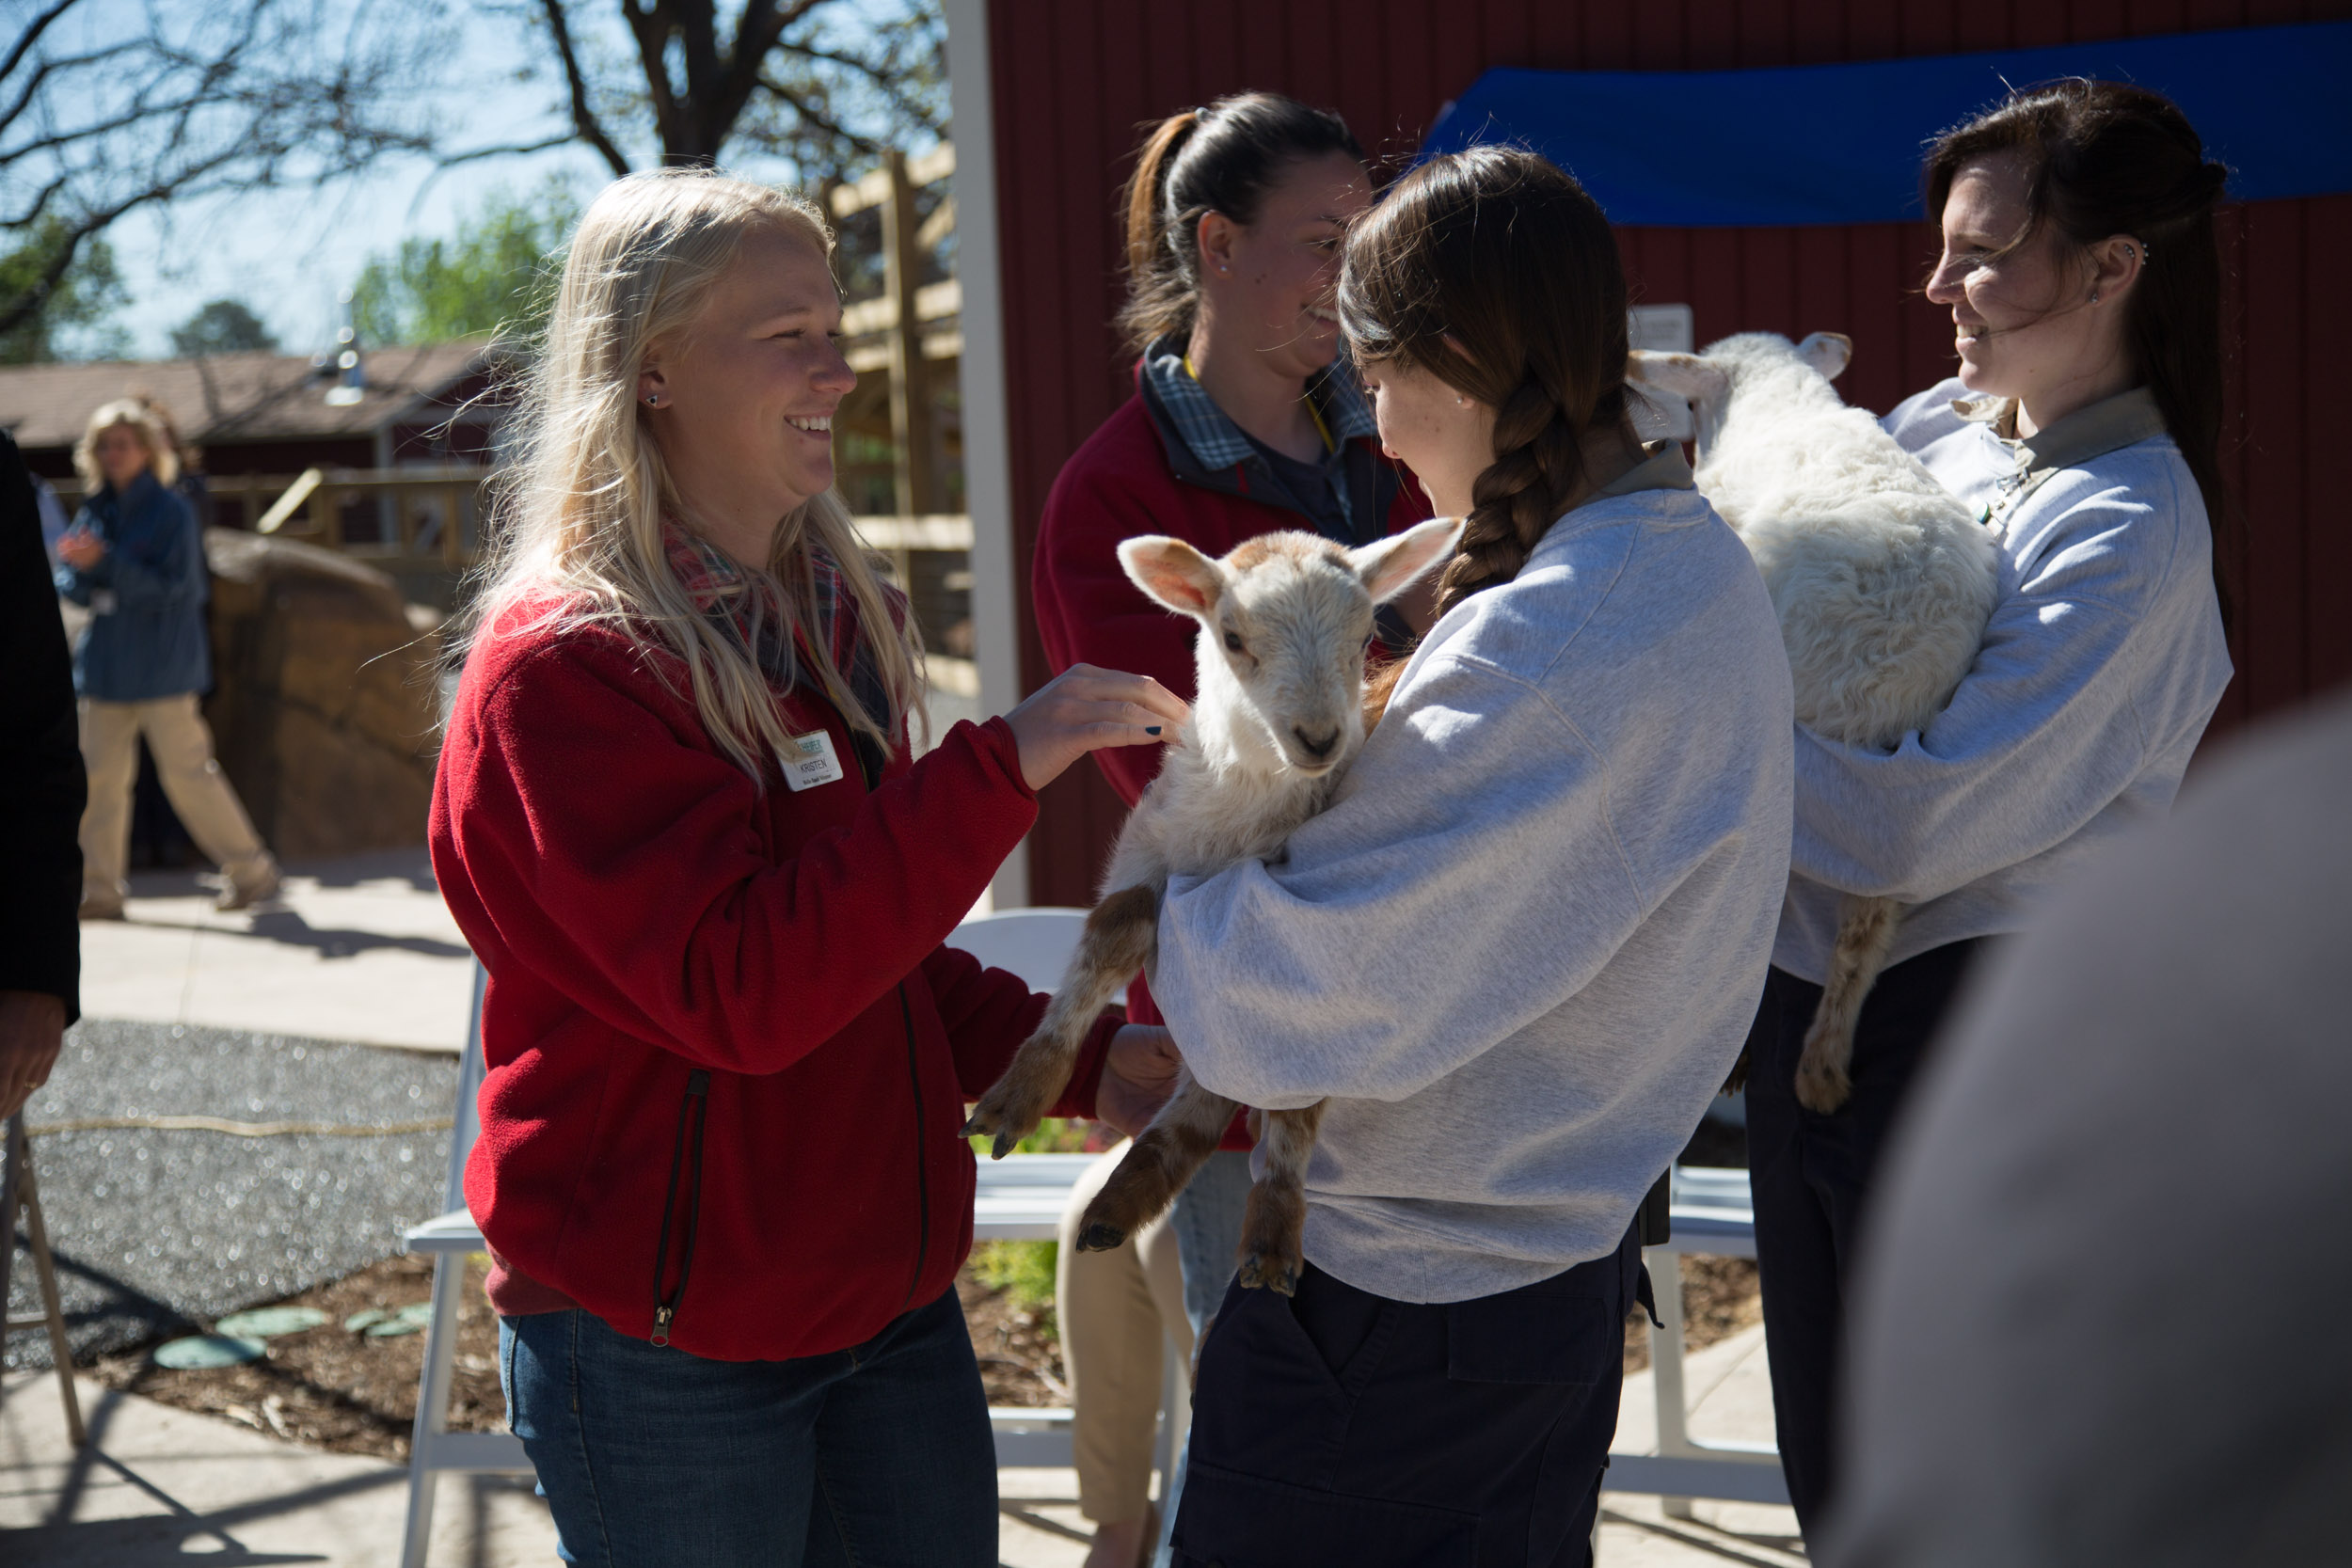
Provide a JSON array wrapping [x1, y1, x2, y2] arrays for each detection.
[[1748, 938, 1983, 1538]]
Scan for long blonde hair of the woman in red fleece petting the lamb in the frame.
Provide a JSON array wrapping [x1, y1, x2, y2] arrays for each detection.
[[475, 169, 922, 781]]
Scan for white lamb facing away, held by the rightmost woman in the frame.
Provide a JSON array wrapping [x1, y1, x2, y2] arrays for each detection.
[[1632, 331, 1997, 1112]]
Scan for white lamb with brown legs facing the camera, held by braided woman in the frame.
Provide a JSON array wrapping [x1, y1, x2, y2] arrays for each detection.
[[964, 517, 1461, 1295]]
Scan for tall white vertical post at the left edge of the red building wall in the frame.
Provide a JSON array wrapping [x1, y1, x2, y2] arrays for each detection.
[[946, 0, 1030, 910]]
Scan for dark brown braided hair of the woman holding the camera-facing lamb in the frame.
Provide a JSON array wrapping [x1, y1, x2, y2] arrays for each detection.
[[1339, 146, 1632, 616]]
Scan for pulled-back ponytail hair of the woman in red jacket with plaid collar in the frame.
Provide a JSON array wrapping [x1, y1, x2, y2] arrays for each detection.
[[1120, 91, 1364, 353]]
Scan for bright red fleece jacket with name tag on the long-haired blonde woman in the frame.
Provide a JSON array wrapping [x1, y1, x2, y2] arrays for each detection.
[[431, 604, 1120, 1361]]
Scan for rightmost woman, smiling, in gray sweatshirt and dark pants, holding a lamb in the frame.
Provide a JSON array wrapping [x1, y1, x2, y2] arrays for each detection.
[[1748, 80, 2230, 1535]]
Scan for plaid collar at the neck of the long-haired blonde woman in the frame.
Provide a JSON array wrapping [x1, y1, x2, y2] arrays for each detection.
[[661, 517, 908, 778]]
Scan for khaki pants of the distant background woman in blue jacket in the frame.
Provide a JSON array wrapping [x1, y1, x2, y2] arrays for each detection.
[[83, 691, 273, 910]]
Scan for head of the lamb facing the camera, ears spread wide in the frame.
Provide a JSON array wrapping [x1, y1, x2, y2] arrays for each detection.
[[1120, 517, 1461, 778]]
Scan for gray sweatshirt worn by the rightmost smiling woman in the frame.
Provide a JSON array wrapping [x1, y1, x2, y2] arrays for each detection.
[[1773, 381, 2230, 983]]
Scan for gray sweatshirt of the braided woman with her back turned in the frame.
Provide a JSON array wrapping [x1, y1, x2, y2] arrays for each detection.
[[1152, 444, 1795, 1303]]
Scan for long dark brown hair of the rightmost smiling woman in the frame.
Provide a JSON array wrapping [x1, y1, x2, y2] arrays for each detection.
[[1927, 77, 2234, 618]]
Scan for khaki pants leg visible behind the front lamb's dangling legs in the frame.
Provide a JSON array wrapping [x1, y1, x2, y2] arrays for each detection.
[[1054, 1143, 1193, 1524]]
